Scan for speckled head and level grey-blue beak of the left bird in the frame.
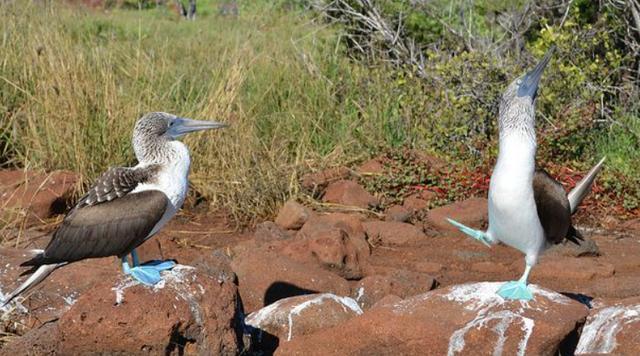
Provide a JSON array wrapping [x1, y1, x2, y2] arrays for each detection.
[[133, 112, 227, 161]]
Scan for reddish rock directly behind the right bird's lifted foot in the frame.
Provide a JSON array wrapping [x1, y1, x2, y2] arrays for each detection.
[[427, 198, 489, 236]]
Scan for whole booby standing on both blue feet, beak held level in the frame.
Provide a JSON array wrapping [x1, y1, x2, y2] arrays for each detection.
[[2, 112, 227, 306]]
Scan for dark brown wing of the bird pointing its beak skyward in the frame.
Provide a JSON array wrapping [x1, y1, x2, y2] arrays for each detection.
[[533, 170, 571, 244]]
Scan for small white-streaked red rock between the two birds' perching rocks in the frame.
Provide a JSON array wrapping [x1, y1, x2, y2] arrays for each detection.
[[245, 293, 362, 341]]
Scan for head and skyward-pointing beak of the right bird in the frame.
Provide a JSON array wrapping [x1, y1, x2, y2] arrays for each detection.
[[499, 46, 555, 136]]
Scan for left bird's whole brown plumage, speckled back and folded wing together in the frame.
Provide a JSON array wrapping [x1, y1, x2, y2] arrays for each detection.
[[22, 165, 169, 267]]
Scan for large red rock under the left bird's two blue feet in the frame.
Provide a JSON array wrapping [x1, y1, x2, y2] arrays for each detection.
[[58, 265, 241, 355]]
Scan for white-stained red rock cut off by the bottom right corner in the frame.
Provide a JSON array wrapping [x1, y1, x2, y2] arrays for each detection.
[[576, 297, 640, 355]]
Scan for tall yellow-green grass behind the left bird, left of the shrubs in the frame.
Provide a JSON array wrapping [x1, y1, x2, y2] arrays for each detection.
[[0, 2, 424, 221]]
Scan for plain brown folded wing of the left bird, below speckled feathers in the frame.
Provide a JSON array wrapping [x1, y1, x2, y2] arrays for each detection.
[[23, 190, 169, 266]]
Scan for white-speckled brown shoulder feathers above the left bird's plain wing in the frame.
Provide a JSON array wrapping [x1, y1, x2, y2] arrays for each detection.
[[75, 165, 160, 209]]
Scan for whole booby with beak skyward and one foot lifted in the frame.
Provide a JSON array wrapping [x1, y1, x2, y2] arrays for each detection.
[[447, 47, 604, 300]]
